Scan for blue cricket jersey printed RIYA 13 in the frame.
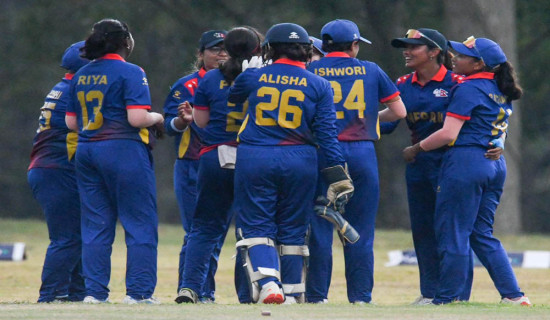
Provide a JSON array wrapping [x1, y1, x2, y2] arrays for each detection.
[[67, 53, 153, 145]]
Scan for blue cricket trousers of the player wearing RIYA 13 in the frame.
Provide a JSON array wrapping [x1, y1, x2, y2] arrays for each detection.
[[76, 139, 158, 300]]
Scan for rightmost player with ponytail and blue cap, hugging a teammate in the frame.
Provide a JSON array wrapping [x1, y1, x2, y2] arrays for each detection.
[[403, 36, 531, 306]]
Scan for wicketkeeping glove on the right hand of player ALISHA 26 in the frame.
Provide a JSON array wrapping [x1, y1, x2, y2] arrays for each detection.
[[321, 165, 354, 213]]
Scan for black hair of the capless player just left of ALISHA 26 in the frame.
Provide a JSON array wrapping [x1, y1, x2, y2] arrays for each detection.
[[220, 27, 261, 83]]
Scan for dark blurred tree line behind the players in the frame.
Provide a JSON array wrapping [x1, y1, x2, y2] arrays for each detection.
[[0, 0, 550, 232]]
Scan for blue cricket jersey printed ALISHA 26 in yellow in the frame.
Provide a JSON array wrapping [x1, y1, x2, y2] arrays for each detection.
[[229, 59, 344, 166]]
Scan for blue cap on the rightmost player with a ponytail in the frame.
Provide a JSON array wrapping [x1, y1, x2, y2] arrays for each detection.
[[449, 36, 507, 68]]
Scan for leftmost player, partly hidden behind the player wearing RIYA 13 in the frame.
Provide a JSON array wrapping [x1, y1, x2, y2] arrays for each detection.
[[27, 41, 90, 302]]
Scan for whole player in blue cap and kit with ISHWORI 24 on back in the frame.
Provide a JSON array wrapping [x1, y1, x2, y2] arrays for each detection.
[[307, 20, 406, 303]]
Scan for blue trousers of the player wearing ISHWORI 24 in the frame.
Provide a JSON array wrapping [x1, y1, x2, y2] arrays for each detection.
[[307, 141, 380, 303]]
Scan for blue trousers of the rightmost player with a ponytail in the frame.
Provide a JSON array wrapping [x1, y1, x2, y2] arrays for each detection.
[[434, 146, 523, 304]]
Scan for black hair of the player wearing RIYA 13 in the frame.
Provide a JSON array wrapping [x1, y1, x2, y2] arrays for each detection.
[[80, 19, 130, 60]]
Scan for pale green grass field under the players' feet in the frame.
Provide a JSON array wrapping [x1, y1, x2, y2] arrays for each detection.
[[0, 219, 550, 320]]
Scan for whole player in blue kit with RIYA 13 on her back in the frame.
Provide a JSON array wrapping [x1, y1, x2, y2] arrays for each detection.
[[65, 19, 164, 304]]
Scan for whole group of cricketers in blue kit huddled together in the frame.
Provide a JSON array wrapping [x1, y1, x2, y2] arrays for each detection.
[[28, 19, 531, 306]]
